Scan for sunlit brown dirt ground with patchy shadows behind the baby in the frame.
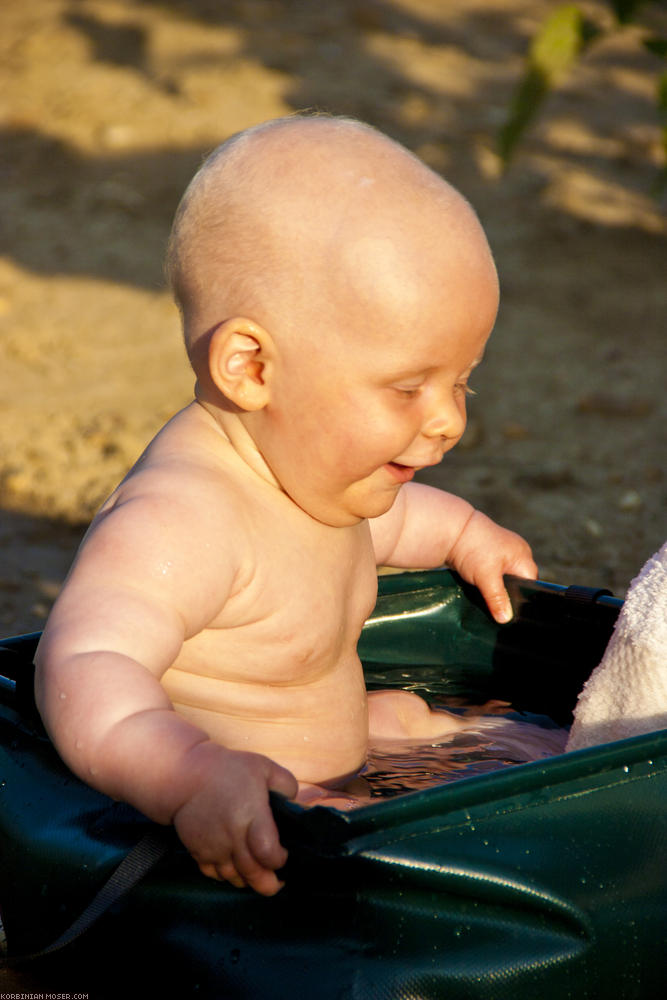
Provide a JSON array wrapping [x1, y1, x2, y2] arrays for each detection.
[[0, 0, 667, 635]]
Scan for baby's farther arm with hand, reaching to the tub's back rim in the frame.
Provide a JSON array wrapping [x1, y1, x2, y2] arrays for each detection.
[[369, 483, 537, 622]]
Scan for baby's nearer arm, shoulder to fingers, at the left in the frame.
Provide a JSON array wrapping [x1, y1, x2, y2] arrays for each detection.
[[36, 497, 297, 895]]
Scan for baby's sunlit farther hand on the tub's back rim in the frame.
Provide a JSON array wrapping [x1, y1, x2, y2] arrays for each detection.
[[447, 510, 537, 623]]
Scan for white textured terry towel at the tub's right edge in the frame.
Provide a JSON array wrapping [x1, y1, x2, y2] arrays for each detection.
[[565, 542, 667, 750]]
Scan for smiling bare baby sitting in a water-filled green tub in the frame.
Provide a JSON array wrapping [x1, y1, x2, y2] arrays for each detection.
[[36, 117, 536, 895]]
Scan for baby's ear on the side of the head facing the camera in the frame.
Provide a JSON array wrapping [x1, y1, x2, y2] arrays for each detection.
[[208, 317, 273, 411]]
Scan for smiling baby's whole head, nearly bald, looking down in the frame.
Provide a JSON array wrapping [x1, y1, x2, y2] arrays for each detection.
[[168, 116, 498, 523]]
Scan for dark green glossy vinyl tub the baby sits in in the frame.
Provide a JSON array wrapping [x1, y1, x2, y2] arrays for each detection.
[[0, 571, 667, 1000]]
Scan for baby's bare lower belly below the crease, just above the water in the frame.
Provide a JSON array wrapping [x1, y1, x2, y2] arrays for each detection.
[[162, 655, 368, 786]]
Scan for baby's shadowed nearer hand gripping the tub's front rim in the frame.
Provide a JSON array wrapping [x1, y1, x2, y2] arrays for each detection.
[[174, 741, 298, 896]]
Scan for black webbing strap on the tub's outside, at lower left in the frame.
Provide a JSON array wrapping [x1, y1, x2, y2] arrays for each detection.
[[9, 827, 175, 964]]
